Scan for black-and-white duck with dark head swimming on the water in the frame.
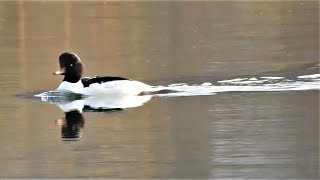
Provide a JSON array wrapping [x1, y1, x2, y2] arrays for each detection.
[[53, 52, 152, 96]]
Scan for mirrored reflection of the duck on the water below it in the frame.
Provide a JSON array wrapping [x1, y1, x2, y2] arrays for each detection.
[[41, 95, 152, 141]]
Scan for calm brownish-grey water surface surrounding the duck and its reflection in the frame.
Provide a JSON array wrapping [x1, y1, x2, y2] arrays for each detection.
[[0, 1, 320, 179]]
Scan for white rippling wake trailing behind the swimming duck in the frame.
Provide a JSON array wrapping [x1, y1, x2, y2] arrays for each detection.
[[155, 74, 320, 97]]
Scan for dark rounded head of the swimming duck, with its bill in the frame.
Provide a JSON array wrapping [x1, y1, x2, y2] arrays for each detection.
[[53, 52, 83, 83]]
